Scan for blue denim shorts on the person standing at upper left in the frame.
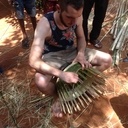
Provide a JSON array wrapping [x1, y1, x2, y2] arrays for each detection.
[[14, 0, 36, 19]]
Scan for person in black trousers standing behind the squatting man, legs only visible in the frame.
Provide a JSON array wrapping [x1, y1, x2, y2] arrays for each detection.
[[83, 0, 109, 49]]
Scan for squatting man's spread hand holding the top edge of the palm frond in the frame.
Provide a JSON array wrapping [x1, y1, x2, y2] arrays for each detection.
[[73, 53, 92, 69]]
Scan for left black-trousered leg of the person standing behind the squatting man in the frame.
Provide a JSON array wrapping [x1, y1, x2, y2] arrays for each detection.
[[83, 0, 94, 42]]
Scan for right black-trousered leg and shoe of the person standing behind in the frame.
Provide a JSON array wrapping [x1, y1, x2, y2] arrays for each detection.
[[90, 0, 109, 48]]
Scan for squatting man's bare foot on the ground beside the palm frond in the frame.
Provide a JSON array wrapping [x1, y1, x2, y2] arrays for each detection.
[[52, 99, 63, 117]]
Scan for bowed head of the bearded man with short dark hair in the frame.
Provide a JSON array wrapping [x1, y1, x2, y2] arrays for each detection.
[[57, 0, 84, 27]]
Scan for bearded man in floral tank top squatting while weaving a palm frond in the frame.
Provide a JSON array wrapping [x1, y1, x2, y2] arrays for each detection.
[[29, 0, 112, 117]]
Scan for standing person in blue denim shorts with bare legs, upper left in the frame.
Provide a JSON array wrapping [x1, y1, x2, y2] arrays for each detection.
[[8, 0, 36, 48]]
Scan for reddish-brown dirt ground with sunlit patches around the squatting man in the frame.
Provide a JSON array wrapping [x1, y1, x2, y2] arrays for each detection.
[[0, 0, 128, 128]]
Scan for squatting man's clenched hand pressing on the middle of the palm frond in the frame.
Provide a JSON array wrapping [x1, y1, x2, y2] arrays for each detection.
[[59, 72, 79, 83]]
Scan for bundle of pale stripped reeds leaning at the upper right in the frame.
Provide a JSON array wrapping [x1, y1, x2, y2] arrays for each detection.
[[110, 0, 128, 65]]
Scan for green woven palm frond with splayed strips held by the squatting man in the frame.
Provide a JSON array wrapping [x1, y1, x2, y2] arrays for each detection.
[[57, 64, 106, 114]]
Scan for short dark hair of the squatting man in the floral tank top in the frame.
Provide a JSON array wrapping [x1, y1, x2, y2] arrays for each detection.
[[58, 0, 84, 10]]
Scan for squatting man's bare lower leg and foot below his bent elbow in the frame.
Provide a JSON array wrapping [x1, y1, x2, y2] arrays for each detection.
[[35, 73, 62, 117]]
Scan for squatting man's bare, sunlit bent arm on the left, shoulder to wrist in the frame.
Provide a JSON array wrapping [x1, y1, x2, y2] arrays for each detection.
[[29, 17, 61, 77]]
